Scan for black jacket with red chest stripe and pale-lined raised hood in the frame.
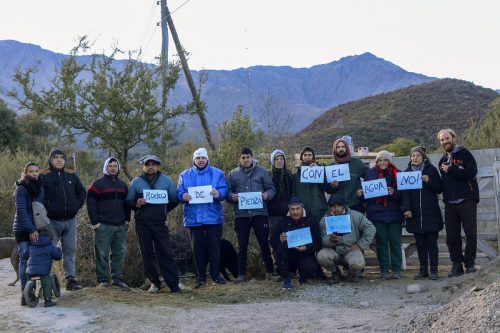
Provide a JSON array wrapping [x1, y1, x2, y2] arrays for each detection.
[[87, 157, 130, 225]]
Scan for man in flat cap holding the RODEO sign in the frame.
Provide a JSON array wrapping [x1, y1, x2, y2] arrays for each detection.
[[126, 155, 181, 293]]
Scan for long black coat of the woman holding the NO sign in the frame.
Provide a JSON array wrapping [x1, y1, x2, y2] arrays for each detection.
[[401, 160, 443, 234]]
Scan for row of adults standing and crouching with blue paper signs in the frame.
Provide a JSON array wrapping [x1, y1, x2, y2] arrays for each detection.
[[14, 129, 479, 303]]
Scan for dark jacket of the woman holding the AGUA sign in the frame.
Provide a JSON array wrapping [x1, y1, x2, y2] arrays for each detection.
[[364, 167, 404, 223]]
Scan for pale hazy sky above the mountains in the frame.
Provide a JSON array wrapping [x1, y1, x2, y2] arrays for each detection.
[[0, 0, 500, 89]]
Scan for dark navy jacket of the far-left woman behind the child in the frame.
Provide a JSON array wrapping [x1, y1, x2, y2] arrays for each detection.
[[12, 182, 44, 234]]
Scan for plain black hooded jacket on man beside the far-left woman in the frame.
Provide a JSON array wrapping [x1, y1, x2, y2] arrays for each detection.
[[40, 149, 86, 220]]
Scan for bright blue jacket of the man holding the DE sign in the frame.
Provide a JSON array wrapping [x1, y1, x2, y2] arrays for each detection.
[[177, 164, 227, 228]]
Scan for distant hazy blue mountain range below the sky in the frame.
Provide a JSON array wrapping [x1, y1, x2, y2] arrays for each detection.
[[0, 40, 435, 134]]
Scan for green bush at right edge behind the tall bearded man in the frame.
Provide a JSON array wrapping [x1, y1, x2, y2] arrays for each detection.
[[464, 97, 500, 149]]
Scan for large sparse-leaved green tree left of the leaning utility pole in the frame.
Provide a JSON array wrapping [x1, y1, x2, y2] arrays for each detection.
[[11, 37, 194, 179]]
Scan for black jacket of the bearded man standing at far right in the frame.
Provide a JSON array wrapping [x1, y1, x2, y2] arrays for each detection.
[[439, 147, 479, 202]]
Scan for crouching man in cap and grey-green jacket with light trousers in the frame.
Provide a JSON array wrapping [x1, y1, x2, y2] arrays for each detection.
[[317, 194, 375, 284]]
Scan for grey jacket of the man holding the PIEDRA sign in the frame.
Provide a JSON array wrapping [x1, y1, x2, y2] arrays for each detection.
[[227, 161, 276, 218]]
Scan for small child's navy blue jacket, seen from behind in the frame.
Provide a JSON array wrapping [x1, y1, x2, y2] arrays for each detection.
[[22, 235, 62, 276]]
